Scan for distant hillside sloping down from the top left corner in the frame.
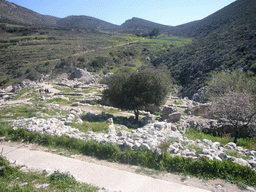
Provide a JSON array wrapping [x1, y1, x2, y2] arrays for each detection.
[[0, 0, 59, 26]]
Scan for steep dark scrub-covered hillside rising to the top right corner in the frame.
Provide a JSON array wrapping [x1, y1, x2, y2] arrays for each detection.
[[158, 0, 256, 97]]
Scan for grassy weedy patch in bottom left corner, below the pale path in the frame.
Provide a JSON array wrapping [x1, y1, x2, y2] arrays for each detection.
[[0, 157, 99, 192]]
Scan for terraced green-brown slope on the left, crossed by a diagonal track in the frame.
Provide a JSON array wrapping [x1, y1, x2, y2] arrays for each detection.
[[0, 26, 189, 85]]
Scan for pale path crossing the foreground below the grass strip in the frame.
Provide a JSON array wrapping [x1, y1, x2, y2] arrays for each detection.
[[0, 142, 249, 192]]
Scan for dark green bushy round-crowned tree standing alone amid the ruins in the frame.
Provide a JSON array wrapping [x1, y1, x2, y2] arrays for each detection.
[[103, 68, 170, 122]]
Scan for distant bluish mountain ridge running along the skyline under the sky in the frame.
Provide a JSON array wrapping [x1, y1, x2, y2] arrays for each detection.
[[0, 0, 247, 37]]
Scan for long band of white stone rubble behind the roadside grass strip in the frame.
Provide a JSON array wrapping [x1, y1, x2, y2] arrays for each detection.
[[12, 117, 256, 170]]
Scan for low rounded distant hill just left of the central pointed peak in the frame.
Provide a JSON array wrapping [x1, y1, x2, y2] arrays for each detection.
[[57, 16, 119, 31]]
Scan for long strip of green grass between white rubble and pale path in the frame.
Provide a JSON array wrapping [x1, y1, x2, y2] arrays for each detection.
[[0, 123, 256, 185]]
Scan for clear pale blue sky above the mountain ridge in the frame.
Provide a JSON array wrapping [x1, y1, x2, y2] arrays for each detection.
[[8, 0, 235, 26]]
